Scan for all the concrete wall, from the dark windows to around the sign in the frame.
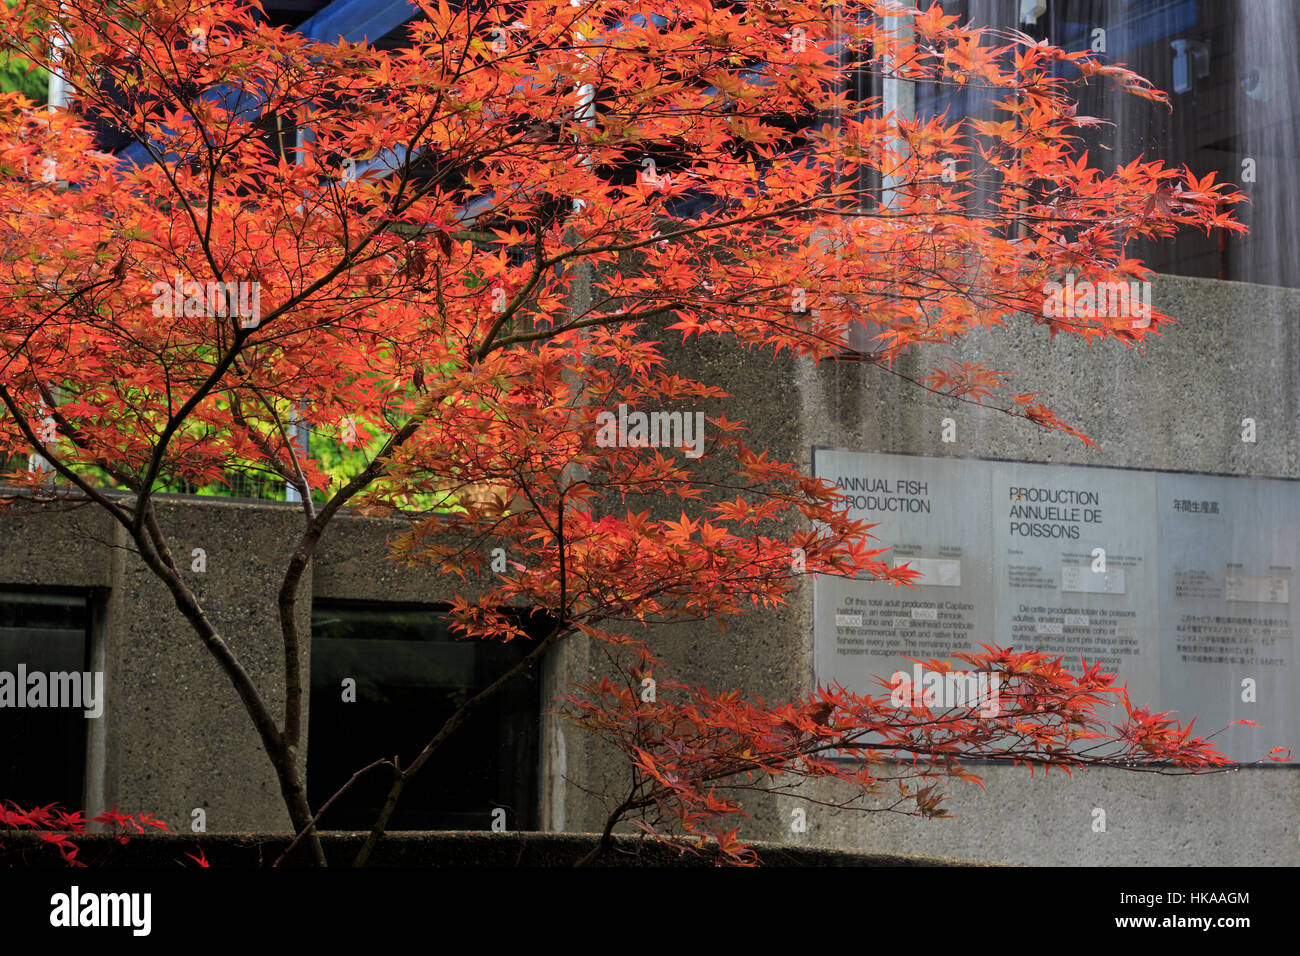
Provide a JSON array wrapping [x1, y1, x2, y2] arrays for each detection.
[[0, 270, 1300, 865]]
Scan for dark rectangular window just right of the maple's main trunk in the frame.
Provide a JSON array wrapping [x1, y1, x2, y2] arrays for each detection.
[[307, 604, 541, 830]]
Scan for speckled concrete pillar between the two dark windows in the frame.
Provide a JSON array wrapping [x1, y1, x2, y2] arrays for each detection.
[[105, 499, 311, 831]]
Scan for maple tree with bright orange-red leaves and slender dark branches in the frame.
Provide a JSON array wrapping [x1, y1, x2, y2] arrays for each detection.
[[0, 0, 1268, 862]]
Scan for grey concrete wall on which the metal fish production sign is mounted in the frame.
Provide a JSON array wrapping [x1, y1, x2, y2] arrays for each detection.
[[546, 270, 1300, 865]]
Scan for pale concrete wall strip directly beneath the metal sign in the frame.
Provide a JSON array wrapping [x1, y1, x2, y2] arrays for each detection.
[[762, 763, 1300, 866]]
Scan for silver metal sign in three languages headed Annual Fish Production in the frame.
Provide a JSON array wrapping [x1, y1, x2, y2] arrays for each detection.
[[813, 449, 1300, 761]]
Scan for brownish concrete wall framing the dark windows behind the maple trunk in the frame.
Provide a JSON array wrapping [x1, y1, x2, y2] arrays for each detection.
[[0, 497, 472, 832]]
